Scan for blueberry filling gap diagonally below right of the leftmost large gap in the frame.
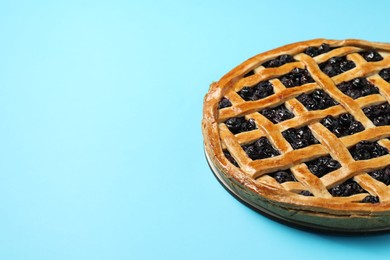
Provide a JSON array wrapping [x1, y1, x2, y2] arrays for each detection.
[[242, 137, 279, 160]]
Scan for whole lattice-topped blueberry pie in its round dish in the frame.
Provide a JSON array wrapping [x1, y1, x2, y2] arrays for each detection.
[[202, 39, 390, 232]]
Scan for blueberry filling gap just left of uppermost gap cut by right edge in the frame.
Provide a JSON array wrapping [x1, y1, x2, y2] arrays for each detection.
[[337, 78, 379, 99]]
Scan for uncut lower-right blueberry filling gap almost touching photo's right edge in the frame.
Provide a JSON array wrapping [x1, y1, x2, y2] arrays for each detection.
[[349, 141, 389, 161]]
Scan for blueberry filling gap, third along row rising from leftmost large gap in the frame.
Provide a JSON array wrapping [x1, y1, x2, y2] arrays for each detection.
[[297, 89, 339, 110]]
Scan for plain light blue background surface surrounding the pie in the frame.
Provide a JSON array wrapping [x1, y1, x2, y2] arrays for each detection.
[[0, 0, 390, 260]]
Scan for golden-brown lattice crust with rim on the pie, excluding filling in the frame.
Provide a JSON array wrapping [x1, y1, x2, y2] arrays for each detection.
[[203, 39, 390, 211]]
